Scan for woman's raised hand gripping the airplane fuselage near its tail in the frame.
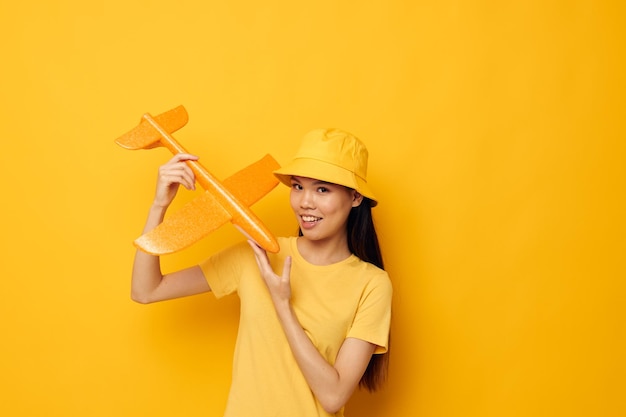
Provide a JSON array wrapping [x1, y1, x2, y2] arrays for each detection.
[[154, 153, 198, 208]]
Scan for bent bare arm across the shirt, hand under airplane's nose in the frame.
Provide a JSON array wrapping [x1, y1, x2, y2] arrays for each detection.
[[249, 241, 376, 414]]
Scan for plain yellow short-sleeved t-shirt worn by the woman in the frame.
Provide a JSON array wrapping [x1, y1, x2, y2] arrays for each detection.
[[200, 237, 392, 417]]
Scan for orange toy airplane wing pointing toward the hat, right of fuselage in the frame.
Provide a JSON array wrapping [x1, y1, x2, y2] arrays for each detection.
[[222, 155, 280, 207]]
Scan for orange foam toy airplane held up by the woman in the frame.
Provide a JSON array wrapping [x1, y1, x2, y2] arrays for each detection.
[[115, 106, 279, 255]]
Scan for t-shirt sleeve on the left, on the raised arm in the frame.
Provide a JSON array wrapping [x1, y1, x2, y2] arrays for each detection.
[[199, 242, 253, 298]]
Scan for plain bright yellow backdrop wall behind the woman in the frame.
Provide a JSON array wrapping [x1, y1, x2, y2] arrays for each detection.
[[0, 0, 626, 417]]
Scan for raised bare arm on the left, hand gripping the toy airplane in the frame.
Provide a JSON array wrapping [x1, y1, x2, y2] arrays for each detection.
[[131, 154, 210, 304]]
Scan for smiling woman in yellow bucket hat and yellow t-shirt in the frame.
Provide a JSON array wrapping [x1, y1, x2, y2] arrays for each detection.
[[132, 129, 392, 417]]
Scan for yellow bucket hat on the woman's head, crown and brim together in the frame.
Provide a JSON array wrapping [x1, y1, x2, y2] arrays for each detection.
[[274, 129, 378, 207]]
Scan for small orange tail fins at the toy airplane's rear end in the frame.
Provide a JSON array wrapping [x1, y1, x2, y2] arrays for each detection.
[[115, 106, 189, 150]]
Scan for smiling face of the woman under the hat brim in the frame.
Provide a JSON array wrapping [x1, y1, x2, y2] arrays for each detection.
[[290, 177, 363, 241]]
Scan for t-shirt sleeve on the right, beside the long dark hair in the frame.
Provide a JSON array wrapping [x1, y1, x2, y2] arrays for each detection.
[[348, 273, 393, 353]]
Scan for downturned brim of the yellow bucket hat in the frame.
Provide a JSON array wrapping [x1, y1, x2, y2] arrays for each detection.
[[274, 158, 378, 207]]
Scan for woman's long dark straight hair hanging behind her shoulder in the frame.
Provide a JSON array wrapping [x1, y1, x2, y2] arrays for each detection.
[[299, 197, 389, 392]]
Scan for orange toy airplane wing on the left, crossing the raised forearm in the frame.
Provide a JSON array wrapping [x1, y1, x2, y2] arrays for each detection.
[[134, 191, 231, 255]]
